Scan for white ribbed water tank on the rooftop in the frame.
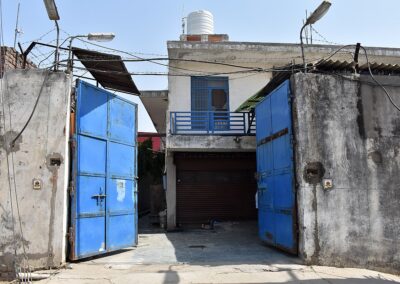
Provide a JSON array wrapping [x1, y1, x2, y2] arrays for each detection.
[[187, 10, 214, 35]]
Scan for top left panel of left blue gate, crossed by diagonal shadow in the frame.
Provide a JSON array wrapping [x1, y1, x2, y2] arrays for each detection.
[[77, 84, 108, 138]]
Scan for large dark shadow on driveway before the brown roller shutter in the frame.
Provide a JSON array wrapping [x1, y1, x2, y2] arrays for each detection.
[[162, 221, 301, 265]]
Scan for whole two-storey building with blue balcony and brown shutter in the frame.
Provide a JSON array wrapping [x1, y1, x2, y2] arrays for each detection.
[[165, 36, 400, 229]]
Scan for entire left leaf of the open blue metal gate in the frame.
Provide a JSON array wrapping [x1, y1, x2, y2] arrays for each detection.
[[70, 81, 137, 260]]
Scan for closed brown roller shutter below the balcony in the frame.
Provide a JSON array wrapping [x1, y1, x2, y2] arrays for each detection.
[[175, 153, 257, 225]]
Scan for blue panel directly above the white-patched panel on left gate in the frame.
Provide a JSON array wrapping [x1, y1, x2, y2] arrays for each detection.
[[108, 142, 136, 178]]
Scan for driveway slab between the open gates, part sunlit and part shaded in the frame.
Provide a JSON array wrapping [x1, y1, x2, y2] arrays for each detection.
[[86, 216, 301, 266]]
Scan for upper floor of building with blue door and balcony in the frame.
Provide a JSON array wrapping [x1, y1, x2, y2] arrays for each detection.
[[141, 38, 400, 151]]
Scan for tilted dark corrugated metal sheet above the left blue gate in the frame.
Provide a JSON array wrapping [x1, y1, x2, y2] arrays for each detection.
[[72, 47, 140, 95]]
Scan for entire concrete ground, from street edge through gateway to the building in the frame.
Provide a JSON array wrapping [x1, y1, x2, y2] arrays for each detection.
[[33, 219, 400, 284]]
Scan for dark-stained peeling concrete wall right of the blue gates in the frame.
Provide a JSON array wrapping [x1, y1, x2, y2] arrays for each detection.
[[291, 73, 400, 273]]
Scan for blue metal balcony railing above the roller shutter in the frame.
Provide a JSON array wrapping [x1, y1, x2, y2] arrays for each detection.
[[170, 111, 256, 136]]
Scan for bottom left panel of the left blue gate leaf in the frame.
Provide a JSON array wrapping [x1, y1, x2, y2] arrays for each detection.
[[75, 214, 106, 256]]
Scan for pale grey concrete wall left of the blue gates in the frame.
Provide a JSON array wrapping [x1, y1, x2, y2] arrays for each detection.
[[0, 70, 71, 272]]
